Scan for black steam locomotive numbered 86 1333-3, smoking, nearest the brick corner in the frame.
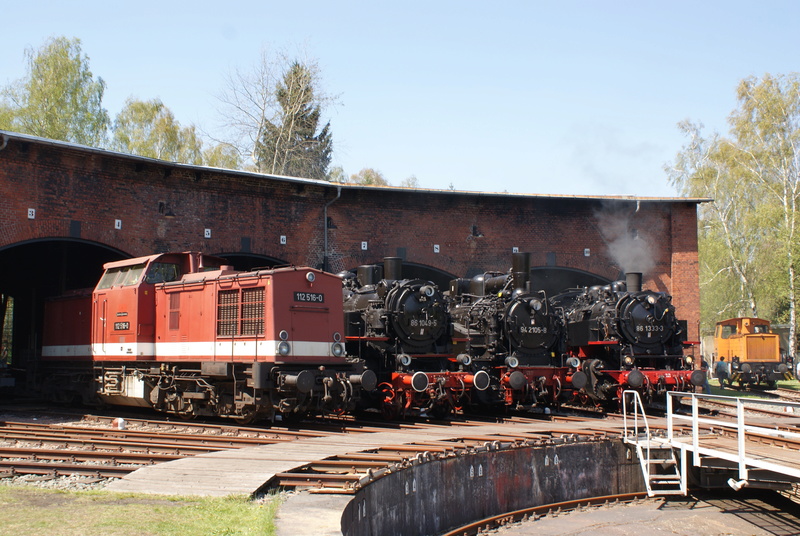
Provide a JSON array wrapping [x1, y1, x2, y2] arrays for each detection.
[[553, 273, 703, 407]]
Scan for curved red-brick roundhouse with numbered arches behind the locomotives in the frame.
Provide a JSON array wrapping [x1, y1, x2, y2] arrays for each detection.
[[0, 132, 705, 372]]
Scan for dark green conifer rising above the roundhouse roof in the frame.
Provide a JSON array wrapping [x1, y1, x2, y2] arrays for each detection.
[[255, 62, 332, 180]]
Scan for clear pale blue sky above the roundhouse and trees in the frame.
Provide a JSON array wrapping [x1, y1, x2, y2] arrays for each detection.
[[0, 0, 800, 197]]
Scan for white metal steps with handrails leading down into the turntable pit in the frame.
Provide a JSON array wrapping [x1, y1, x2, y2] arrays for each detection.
[[623, 391, 687, 497]]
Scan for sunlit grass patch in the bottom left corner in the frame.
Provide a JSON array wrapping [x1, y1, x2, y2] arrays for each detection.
[[0, 485, 280, 536]]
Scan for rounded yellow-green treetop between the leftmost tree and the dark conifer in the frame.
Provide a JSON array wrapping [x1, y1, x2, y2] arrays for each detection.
[[111, 98, 203, 165]]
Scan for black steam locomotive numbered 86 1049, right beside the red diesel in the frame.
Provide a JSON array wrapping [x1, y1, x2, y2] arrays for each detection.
[[340, 257, 490, 418]]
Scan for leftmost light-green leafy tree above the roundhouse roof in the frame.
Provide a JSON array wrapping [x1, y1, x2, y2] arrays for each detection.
[[0, 37, 110, 147]]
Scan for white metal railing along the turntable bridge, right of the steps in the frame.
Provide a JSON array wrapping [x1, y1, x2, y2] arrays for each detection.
[[666, 392, 800, 489]]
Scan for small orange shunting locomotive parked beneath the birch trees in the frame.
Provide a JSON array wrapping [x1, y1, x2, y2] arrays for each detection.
[[714, 317, 792, 387]]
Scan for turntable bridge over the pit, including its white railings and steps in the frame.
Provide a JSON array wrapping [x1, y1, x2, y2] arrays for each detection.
[[623, 391, 800, 497]]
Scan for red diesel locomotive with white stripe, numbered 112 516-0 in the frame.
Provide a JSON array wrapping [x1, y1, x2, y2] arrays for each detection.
[[42, 252, 376, 422]]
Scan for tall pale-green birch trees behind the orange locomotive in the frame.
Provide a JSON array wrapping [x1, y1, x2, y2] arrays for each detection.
[[670, 74, 800, 355]]
